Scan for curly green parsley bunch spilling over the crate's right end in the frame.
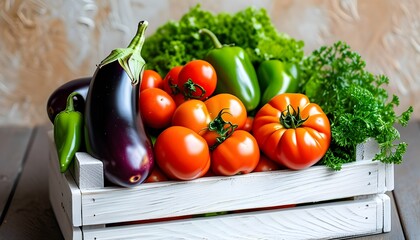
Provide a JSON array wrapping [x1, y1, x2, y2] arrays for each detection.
[[301, 41, 413, 170]]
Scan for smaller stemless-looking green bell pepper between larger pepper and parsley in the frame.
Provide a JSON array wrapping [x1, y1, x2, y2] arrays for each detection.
[[257, 59, 299, 106]]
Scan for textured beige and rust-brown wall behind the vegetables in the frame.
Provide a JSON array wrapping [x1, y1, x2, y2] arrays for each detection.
[[0, 0, 420, 125]]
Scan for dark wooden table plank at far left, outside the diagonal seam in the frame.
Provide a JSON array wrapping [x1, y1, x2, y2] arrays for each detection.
[[0, 127, 32, 224]]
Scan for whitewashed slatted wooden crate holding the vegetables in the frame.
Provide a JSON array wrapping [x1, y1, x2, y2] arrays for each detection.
[[49, 134, 394, 240]]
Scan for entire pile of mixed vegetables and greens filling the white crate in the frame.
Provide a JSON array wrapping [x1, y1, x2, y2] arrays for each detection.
[[47, 6, 413, 187]]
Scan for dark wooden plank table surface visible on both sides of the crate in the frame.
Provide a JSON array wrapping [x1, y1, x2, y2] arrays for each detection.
[[0, 122, 420, 240]]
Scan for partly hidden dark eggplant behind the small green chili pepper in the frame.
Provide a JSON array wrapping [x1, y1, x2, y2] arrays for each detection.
[[47, 77, 92, 123]]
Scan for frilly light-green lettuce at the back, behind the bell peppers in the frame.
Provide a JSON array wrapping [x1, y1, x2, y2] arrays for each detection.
[[142, 5, 304, 76]]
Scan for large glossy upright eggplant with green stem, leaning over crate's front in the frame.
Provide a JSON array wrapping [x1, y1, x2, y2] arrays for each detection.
[[84, 21, 154, 187]]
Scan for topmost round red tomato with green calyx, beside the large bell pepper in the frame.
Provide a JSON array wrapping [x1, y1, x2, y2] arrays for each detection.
[[178, 59, 217, 100]]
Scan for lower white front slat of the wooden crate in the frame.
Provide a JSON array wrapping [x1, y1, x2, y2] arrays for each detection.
[[84, 198, 389, 240]]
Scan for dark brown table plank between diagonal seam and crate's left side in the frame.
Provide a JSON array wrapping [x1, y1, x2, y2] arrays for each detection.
[[0, 126, 63, 239]]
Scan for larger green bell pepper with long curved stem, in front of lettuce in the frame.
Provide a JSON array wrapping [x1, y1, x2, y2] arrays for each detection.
[[200, 29, 261, 111]]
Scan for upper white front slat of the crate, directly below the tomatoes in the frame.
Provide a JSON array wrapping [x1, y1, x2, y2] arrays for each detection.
[[81, 161, 383, 225]]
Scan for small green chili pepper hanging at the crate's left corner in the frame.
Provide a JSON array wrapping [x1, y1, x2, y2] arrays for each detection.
[[54, 92, 83, 173]]
